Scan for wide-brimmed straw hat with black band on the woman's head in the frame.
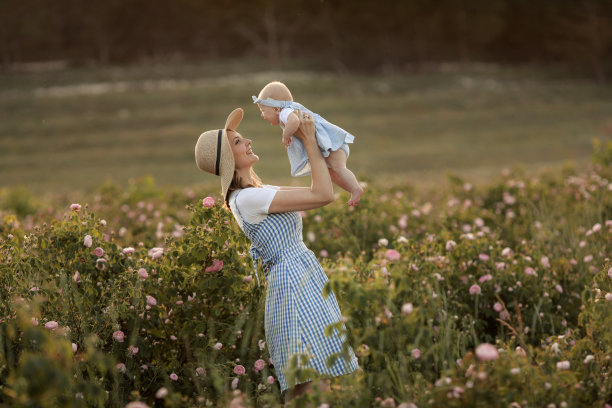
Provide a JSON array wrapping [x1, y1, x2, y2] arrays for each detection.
[[195, 108, 244, 199]]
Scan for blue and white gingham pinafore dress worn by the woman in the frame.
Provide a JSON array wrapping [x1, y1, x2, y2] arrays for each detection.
[[230, 190, 358, 392]]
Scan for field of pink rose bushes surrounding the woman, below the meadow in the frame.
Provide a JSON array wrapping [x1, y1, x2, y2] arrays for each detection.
[[0, 143, 612, 408]]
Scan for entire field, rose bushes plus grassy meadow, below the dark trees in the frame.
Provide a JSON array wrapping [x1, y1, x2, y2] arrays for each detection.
[[0, 65, 612, 408]]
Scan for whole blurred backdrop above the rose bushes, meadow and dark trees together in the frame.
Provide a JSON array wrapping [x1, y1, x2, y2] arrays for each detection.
[[0, 0, 612, 193]]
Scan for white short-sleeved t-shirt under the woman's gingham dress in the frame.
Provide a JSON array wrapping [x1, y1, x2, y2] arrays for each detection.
[[229, 184, 280, 225]]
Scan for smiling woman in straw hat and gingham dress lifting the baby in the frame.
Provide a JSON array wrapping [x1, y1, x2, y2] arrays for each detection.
[[195, 109, 358, 401]]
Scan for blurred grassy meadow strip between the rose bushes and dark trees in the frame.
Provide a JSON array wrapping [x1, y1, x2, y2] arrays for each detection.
[[0, 62, 612, 192]]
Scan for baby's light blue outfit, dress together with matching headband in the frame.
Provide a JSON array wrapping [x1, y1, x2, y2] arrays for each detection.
[[253, 96, 355, 177]]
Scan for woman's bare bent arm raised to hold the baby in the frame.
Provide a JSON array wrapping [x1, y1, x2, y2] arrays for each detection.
[[268, 112, 334, 213]]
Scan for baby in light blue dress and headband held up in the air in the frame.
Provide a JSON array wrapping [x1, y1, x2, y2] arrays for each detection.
[[253, 81, 363, 206]]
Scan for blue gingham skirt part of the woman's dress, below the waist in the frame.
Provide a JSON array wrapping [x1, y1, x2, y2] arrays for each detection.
[[265, 242, 358, 391]]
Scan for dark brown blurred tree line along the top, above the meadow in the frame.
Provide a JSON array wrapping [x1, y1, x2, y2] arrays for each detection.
[[0, 0, 612, 81]]
